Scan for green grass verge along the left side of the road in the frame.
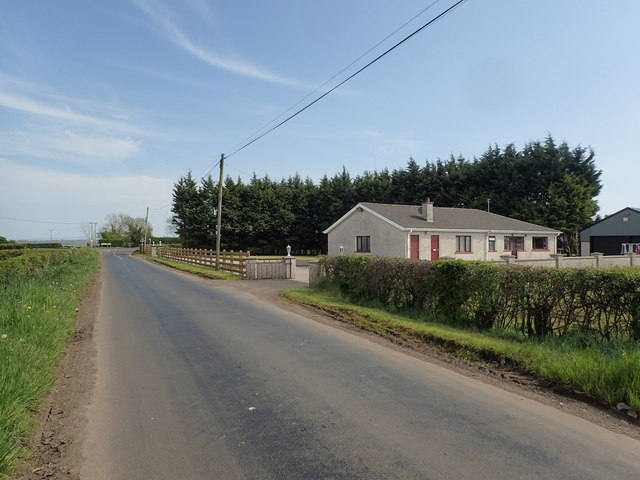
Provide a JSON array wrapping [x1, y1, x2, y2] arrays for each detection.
[[0, 249, 99, 479]]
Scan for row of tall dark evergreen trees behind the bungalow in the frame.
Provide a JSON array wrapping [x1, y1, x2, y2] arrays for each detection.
[[170, 136, 602, 254]]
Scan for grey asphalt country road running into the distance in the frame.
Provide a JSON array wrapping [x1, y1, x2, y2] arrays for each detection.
[[81, 254, 640, 480]]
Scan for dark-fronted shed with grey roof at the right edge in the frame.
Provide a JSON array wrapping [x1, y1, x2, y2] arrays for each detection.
[[580, 207, 640, 256]]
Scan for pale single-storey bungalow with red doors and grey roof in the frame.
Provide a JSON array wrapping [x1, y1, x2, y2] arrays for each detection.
[[324, 199, 560, 261]]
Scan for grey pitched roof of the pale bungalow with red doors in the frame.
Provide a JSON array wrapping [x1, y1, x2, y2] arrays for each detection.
[[324, 202, 560, 234]]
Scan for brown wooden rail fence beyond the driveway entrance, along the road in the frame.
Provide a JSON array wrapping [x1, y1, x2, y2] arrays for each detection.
[[151, 246, 251, 277]]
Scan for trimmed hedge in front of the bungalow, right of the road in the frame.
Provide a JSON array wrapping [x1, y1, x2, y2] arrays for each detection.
[[321, 255, 640, 341]]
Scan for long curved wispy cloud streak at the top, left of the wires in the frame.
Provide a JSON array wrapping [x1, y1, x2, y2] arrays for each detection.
[[133, 0, 313, 89]]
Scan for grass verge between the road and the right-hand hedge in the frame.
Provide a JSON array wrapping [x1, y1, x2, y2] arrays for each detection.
[[282, 288, 640, 411]]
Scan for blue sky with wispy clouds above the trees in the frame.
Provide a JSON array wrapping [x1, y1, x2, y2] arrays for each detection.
[[0, 0, 640, 241]]
